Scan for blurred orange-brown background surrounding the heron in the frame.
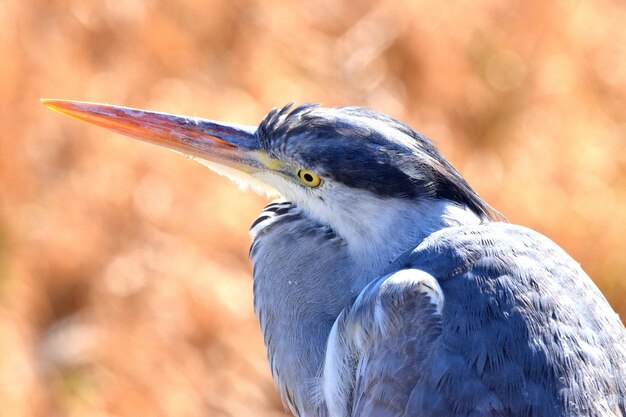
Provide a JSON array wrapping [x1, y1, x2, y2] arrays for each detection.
[[0, 0, 626, 417]]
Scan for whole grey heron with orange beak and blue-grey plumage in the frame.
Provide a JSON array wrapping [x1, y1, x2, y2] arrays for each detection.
[[42, 99, 626, 417]]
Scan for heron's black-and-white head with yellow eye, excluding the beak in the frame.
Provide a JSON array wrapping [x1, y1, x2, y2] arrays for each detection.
[[255, 104, 492, 218]]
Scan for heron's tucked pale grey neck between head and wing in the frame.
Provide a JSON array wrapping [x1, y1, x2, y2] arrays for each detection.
[[251, 201, 480, 417]]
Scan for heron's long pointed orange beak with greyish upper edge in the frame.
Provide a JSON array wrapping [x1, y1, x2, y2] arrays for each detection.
[[41, 99, 263, 173]]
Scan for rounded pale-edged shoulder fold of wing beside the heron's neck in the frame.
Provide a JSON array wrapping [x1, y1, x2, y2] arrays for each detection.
[[323, 269, 444, 417]]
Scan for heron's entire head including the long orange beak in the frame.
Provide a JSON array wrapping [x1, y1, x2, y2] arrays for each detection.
[[43, 100, 492, 245]]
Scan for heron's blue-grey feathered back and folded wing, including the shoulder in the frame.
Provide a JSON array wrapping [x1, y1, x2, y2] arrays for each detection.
[[324, 223, 626, 417]]
